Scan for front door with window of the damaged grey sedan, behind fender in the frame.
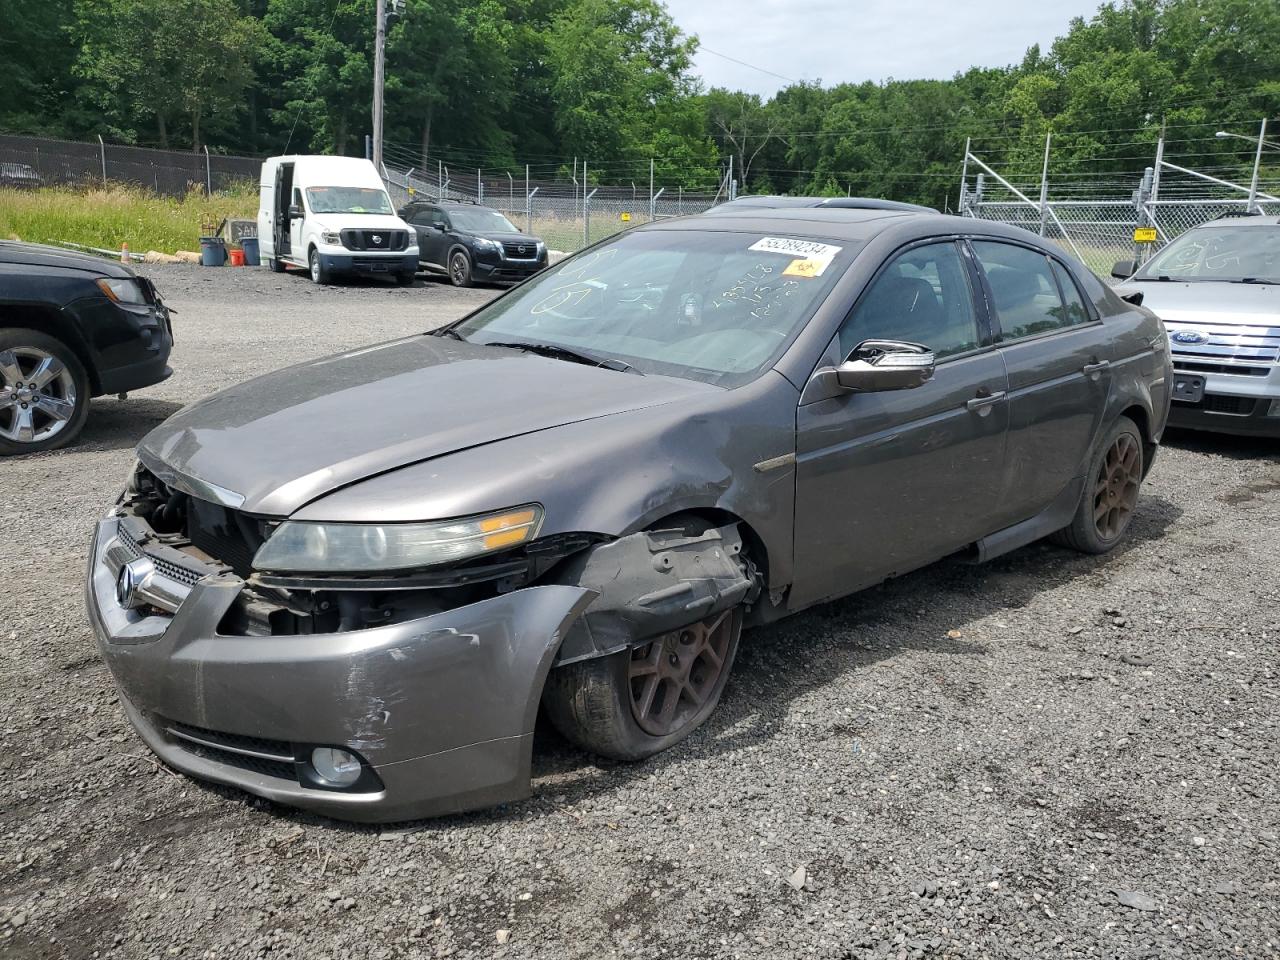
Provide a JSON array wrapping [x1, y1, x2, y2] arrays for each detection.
[[791, 241, 1009, 608]]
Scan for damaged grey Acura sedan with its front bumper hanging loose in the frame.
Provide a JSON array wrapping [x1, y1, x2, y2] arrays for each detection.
[[88, 209, 1172, 820]]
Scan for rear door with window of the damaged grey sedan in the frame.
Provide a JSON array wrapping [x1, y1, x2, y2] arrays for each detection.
[[972, 239, 1112, 526]]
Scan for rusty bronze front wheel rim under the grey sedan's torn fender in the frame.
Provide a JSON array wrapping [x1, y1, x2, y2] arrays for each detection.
[[627, 611, 735, 737]]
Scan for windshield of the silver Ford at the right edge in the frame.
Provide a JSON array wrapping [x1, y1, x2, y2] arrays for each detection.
[[1135, 224, 1280, 283]]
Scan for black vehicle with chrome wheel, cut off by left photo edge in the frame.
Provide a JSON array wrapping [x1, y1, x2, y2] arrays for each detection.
[[0, 241, 173, 457]]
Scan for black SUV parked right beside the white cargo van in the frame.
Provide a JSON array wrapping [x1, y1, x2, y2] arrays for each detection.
[[399, 200, 547, 287]]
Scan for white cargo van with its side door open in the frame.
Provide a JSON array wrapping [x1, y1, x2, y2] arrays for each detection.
[[257, 156, 417, 285]]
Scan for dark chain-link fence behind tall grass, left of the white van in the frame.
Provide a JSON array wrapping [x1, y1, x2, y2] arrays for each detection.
[[0, 134, 262, 197]]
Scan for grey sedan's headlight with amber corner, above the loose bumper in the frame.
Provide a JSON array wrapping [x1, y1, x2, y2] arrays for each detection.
[[253, 504, 543, 573]]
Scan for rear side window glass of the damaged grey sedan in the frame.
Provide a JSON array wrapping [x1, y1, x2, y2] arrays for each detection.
[[973, 241, 1089, 340]]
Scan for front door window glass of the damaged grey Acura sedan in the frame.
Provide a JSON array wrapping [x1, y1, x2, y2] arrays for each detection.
[[840, 241, 980, 357]]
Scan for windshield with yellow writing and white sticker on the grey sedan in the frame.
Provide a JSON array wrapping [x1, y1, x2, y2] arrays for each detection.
[[452, 230, 860, 387]]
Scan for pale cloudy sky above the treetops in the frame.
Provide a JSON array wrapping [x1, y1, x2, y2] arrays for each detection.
[[666, 0, 1101, 96]]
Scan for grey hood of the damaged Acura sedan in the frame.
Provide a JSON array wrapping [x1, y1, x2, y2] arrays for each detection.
[[138, 335, 721, 516]]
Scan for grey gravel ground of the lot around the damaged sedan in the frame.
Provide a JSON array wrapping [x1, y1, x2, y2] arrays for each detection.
[[0, 268, 1280, 960]]
